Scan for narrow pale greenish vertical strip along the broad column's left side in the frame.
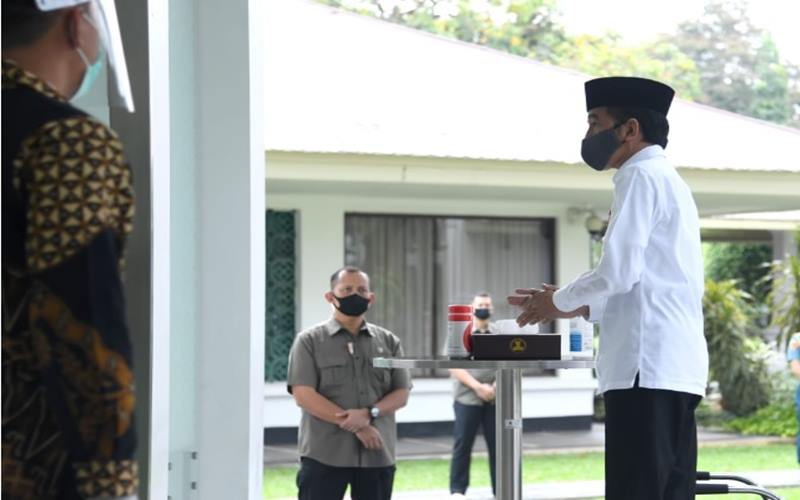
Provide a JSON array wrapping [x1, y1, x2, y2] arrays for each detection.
[[169, 0, 200, 494]]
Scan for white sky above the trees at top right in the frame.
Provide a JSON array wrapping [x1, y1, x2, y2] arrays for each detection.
[[558, 0, 800, 64]]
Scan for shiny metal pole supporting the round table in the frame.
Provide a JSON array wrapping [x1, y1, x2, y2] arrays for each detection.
[[495, 369, 522, 500]]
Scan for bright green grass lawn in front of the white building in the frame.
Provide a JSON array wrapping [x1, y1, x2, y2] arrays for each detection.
[[264, 444, 800, 500]]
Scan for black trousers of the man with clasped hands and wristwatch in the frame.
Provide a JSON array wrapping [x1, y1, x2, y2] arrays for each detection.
[[297, 457, 395, 500]]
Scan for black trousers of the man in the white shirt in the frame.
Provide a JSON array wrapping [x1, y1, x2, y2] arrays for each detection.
[[604, 377, 701, 500]]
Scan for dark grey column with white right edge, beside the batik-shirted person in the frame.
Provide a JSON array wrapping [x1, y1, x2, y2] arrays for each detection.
[[110, 0, 170, 499]]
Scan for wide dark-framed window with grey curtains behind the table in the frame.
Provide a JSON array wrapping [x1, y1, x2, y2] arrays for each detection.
[[345, 214, 554, 376]]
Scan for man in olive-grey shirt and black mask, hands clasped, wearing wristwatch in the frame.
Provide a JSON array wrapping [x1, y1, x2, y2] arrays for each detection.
[[287, 267, 411, 500]]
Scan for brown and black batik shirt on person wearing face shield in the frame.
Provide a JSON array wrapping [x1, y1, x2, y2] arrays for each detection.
[[2, 60, 138, 499]]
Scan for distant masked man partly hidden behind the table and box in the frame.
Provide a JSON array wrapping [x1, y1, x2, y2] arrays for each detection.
[[450, 293, 497, 498]]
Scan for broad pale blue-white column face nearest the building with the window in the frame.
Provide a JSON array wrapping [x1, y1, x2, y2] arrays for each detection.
[[194, 0, 266, 500]]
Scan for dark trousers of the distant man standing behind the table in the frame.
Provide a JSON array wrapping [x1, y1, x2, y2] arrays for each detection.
[[450, 401, 496, 493]]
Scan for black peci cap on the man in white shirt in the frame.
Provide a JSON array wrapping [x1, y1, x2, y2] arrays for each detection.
[[584, 76, 675, 116]]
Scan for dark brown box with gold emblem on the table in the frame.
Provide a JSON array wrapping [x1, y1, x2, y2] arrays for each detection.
[[472, 333, 561, 359]]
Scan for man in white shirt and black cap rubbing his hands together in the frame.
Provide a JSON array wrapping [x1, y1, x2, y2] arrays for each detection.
[[509, 77, 708, 500]]
